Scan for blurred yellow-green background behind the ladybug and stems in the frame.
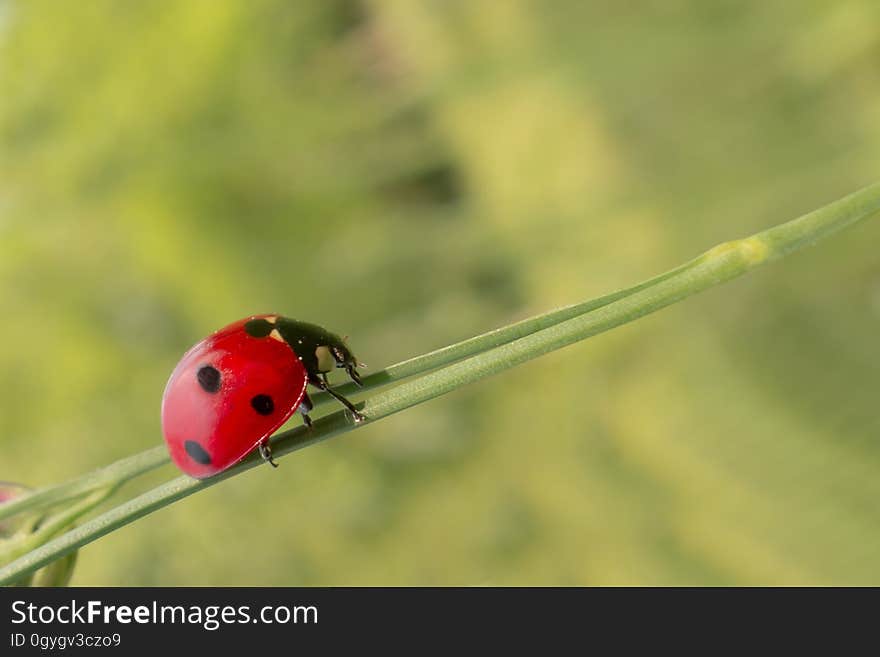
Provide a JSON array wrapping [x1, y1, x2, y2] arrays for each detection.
[[0, 0, 880, 585]]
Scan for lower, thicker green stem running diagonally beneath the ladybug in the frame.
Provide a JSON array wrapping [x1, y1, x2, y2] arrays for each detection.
[[0, 183, 880, 584]]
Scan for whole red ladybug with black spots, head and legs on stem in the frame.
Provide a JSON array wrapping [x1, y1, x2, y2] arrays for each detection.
[[162, 315, 364, 479]]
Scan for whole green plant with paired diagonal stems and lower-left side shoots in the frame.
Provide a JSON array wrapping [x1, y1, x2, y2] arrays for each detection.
[[0, 183, 880, 584]]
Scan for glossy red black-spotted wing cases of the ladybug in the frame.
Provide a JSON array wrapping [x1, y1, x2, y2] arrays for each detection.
[[162, 315, 308, 479]]
